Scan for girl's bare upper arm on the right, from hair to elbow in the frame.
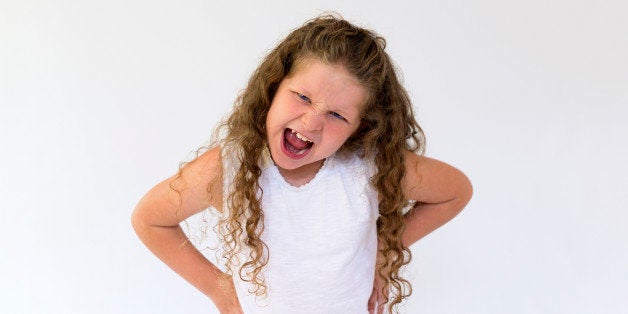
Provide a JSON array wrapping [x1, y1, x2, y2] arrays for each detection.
[[402, 151, 472, 203]]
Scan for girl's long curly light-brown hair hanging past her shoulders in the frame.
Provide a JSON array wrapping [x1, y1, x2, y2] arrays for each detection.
[[217, 15, 425, 312]]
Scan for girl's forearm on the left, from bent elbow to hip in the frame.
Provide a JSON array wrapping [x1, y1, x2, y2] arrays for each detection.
[[133, 223, 239, 313]]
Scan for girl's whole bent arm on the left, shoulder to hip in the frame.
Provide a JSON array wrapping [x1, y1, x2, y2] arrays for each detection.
[[131, 148, 241, 313]]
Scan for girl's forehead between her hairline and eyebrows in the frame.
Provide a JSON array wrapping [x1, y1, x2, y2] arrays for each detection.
[[284, 58, 368, 110]]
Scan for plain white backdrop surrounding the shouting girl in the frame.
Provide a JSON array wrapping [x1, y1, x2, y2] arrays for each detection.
[[0, 0, 628, 314]]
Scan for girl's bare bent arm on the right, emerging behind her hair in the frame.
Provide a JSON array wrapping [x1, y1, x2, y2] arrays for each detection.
[[402, 152, 473, 247]]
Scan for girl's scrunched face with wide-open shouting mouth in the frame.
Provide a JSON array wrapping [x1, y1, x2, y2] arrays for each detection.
[[266, 58, 368, 181]]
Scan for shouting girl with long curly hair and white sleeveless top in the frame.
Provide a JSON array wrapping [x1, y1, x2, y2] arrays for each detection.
[[132, 16, 472, 313]]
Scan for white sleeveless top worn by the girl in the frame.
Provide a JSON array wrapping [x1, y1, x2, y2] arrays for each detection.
[[223, 148, 378, 314]]
